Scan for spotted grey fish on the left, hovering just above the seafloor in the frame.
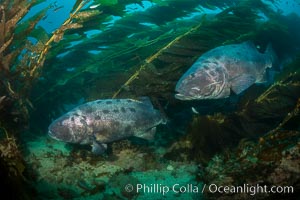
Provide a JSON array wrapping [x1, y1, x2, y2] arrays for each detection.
[[49, 98, 165, 154]]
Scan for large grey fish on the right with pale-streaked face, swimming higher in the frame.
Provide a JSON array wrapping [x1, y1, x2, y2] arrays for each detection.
[[175, 41, 276, 100]]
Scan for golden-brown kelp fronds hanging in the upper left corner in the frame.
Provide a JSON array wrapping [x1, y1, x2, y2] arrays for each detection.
[[0, 0, 94, 124]]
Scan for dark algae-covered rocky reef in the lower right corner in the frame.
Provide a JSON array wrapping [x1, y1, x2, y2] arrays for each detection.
[[199, 130, 300, 199]]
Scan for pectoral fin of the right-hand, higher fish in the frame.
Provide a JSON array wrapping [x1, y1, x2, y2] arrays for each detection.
[[231, 74, 256, 94]]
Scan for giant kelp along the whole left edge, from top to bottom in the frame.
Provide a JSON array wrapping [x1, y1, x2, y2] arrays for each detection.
[[0, 0, 98, 199]]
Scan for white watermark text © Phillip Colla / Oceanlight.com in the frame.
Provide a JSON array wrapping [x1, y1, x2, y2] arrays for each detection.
[[124, 183, 294, 196]]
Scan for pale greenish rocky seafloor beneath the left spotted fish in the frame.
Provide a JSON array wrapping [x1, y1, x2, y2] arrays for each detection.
[[25, 137, 202, 199]]
